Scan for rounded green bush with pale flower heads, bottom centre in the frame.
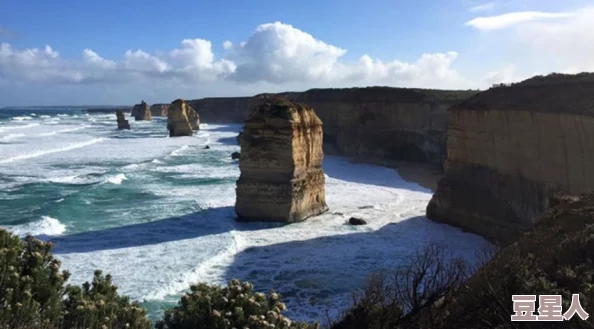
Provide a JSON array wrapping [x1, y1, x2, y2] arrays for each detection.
[[156, 280, 319, 329]]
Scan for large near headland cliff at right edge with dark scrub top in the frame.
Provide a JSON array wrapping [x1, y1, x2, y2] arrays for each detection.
[[427, 74, 594, 243]]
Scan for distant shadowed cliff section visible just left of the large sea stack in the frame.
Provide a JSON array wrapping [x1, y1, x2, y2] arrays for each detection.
[[188, 97, 250, 123]]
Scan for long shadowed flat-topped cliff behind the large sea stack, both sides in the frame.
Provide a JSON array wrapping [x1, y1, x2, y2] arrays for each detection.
[[190, 87, 476, 166]]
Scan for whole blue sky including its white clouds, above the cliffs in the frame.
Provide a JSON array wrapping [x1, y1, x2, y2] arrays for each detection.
[[0, 0, 594, 106]]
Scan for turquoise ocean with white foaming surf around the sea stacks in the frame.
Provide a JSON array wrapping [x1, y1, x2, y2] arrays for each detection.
[[0, 108, 488, 321]]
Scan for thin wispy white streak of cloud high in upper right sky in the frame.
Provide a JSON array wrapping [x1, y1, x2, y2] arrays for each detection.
[[465, 11, 574, 31]]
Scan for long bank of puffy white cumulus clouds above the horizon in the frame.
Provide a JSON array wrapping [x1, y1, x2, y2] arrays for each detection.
[[0, 22, 473, 103]]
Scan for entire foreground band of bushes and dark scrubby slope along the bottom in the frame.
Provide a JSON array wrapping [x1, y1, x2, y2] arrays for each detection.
[[0, 187, 594, 329]]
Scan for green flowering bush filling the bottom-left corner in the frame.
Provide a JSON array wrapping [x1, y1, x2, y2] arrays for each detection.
[[0, 228, 152, 329]]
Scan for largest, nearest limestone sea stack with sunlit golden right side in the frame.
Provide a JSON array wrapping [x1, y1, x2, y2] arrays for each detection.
[[235, 96, 328, 223]]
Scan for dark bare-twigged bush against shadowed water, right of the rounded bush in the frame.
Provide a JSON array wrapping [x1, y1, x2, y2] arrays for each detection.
[[328, 243, 468, 329]]
